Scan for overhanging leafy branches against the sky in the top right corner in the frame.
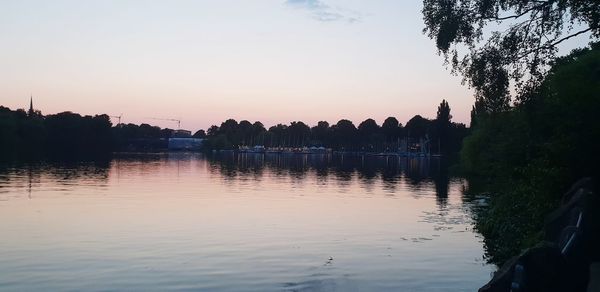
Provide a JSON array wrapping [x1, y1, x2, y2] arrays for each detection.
[[422, 0, 600, 112]]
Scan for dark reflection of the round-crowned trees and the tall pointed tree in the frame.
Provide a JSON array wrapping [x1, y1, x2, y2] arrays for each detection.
[[209, 152, 450, 208]]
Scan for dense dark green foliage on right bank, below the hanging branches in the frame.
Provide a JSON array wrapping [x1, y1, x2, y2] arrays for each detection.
[[461, 44, 600, 263]]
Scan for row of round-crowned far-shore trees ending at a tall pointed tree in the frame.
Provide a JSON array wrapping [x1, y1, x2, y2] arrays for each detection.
[[205, 100, 468, 154]]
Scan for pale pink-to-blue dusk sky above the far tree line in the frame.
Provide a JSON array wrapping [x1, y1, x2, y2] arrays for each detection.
[[0, 0, 588, 130]]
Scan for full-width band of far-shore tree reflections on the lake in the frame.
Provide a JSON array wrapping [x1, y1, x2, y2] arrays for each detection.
[[0, 152, 458, 209]]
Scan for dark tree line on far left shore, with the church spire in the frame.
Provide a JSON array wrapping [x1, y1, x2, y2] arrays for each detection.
[[0, 106, 173, 160]]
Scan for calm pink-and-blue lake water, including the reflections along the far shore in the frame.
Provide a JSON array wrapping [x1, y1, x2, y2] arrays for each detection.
[[0, 154, 494, 291]]
